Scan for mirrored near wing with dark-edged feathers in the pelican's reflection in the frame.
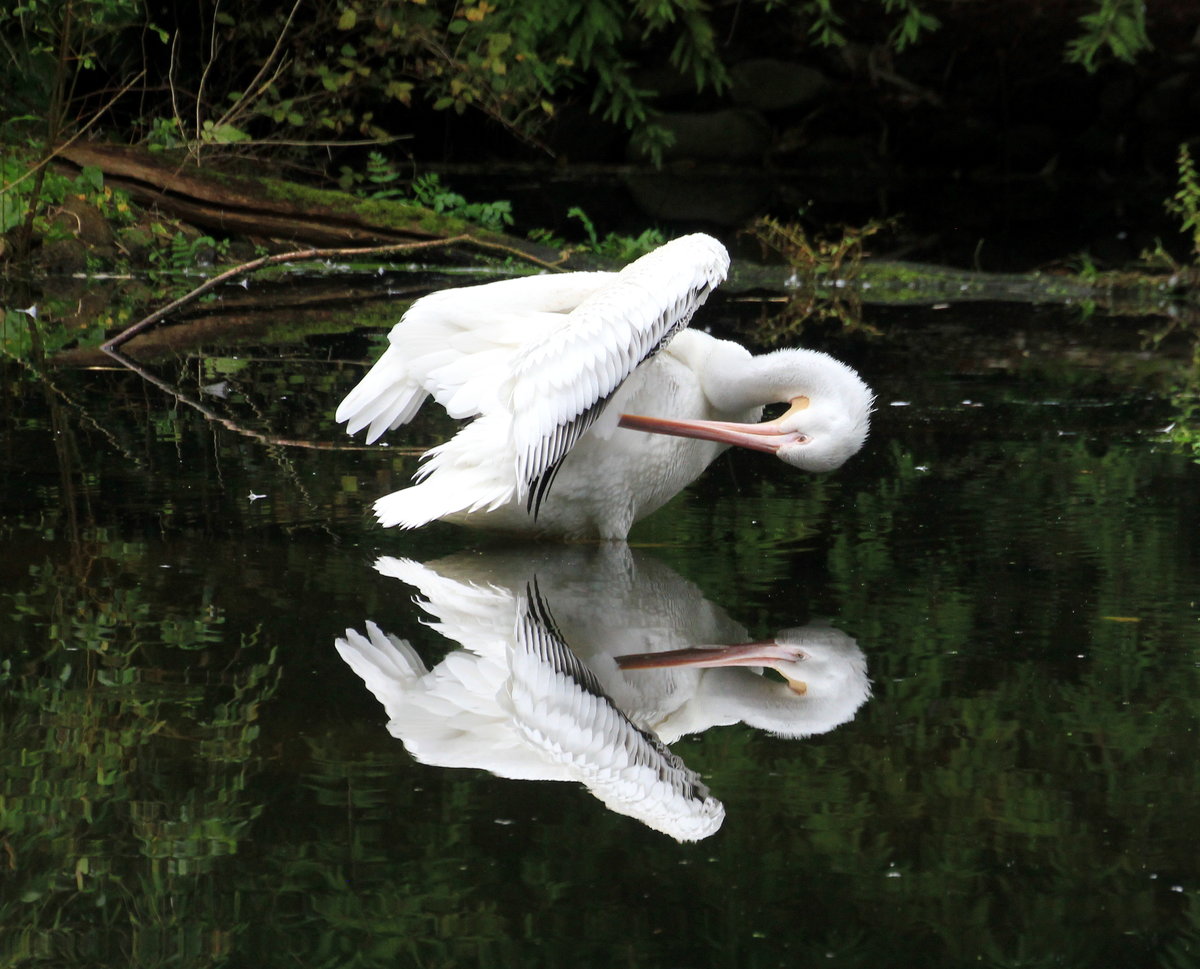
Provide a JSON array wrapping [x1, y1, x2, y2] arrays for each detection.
[[510, 585, 725, 841]]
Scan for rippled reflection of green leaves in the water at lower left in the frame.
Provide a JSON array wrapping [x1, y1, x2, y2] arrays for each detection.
[[0, 594, 280, 965]]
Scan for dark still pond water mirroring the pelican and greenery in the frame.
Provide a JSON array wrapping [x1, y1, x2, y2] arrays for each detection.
[[0, 287, 1200, 969]]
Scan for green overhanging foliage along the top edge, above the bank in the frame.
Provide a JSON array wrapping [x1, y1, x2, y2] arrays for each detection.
[[0, 0, 1150, 182]]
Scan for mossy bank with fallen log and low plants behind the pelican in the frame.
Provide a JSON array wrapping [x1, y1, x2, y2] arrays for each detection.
[[0, 143, 1200, 359]]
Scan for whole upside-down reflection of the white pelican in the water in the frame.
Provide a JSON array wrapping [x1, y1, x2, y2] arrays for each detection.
[[336, 546, 870, 841]]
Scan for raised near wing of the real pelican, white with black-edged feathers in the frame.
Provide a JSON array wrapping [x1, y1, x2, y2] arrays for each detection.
[[500, 234, 730, 513]]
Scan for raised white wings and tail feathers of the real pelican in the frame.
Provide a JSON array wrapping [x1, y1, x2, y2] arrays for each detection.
[[337, 234, 728, 528]]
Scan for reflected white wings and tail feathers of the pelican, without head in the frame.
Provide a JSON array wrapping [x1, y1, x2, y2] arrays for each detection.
[[336, 559, 725, 841]]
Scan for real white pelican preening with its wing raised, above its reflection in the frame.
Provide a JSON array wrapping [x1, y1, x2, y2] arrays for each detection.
[[336, 234, 872, 540]]
